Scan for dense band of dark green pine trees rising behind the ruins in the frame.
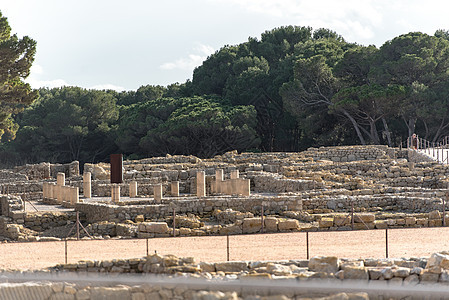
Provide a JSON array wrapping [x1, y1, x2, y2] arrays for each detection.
[[1, 18, 449, 163]]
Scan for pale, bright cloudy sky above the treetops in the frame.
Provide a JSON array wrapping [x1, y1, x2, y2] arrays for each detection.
[[0, 0, 449, 90]]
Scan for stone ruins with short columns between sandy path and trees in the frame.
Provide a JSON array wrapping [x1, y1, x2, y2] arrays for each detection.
[[0, 146, 449, 240]]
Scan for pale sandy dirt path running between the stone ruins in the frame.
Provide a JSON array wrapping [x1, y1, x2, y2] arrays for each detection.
[[0, 227, 449, 270]]
